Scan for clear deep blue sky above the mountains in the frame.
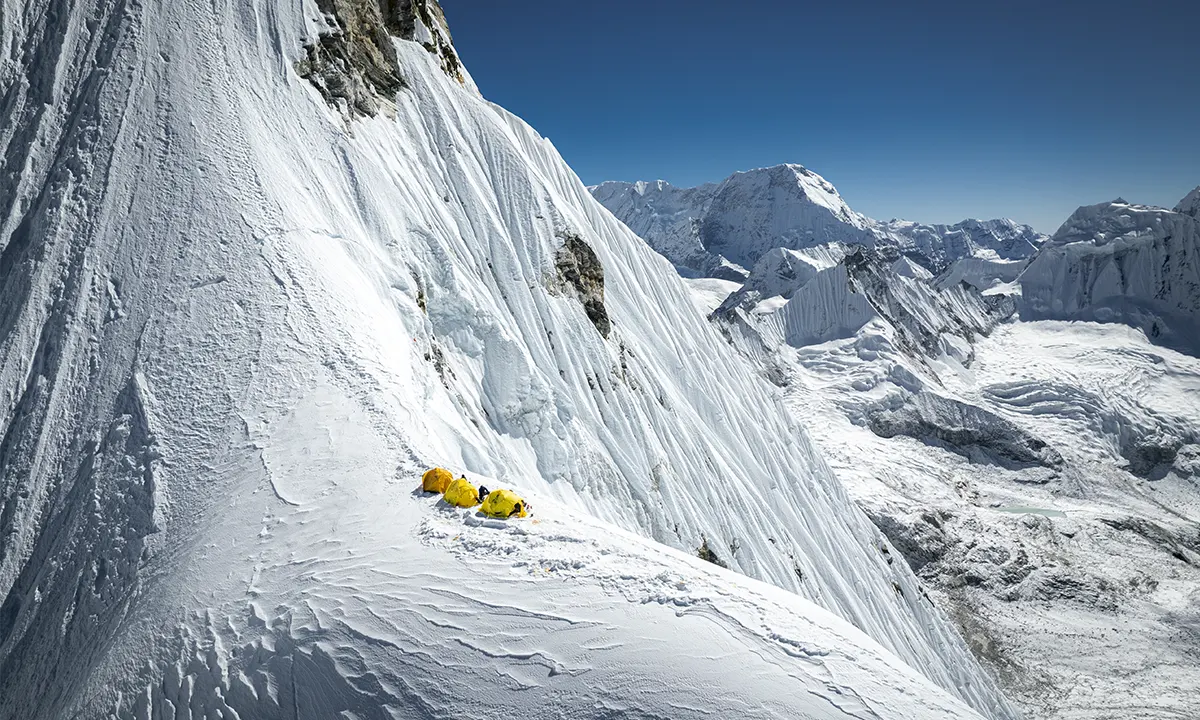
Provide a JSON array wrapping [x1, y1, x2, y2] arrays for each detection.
[[442, 0, 1200, 232]]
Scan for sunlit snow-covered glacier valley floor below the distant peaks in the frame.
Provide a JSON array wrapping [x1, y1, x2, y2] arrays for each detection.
[[772, 322, 1200, 720]]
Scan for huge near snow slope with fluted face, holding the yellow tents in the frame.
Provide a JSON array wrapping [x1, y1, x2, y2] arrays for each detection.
[[0, 0, 1015, 719]]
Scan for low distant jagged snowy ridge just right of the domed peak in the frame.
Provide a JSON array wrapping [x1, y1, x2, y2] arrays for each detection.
[[882, 218, 1046, 268]]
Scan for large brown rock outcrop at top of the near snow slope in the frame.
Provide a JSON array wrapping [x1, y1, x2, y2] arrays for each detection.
[[295, 0, 467, 115]]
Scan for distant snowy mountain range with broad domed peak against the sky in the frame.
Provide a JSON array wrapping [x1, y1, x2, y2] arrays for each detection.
[[590, 164, 1045, 280]]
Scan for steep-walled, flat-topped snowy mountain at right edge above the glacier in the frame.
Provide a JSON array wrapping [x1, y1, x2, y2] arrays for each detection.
[[1020, 202, 1200, 353]]
